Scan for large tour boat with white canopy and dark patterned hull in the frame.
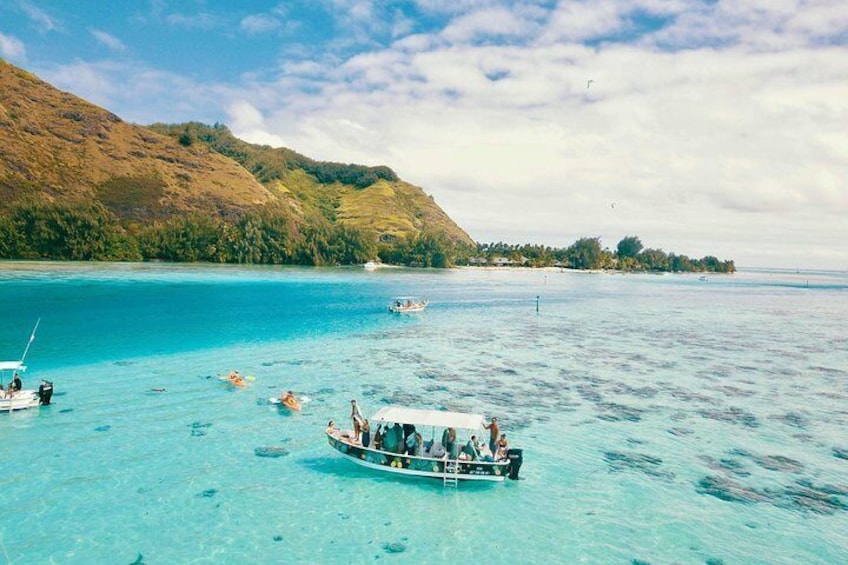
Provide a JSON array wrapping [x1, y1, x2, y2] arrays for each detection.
[[326, 406, 522, 486]]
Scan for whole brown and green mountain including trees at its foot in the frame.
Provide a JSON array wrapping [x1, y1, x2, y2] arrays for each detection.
[[0, 59, 473, 266]]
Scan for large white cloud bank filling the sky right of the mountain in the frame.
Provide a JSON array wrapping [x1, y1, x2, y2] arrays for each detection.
[[222, 1, 848, 265]]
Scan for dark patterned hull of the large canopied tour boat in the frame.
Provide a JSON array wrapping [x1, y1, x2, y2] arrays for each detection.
[[327, 432, 509, 482]]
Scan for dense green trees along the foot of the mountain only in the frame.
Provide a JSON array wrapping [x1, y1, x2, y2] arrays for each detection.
[[0, 202, 458, 268]]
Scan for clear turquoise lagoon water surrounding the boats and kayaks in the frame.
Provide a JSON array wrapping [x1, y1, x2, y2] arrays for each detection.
[[0, 263, 848, 565]]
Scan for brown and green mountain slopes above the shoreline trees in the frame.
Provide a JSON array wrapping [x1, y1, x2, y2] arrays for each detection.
[[0, 59, 473, 262]]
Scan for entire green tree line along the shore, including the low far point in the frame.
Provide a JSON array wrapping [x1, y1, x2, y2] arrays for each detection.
[[0, 202, 736, 273]]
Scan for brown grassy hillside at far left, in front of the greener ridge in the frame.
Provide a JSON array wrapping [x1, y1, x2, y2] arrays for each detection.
[[0, 60, 276, 220]]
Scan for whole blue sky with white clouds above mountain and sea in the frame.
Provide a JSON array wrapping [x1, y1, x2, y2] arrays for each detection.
[[0, 0, 848, 270]]
